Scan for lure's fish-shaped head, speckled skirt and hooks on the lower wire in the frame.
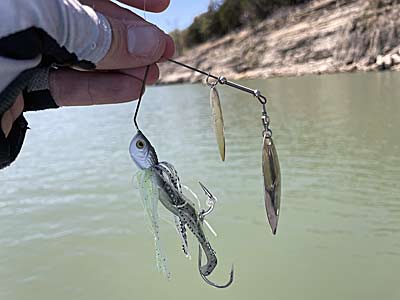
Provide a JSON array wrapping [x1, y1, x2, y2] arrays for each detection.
[[129, 67, 234, 288]]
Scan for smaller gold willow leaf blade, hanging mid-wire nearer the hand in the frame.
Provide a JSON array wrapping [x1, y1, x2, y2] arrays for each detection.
[[210, 87, 225, 161]]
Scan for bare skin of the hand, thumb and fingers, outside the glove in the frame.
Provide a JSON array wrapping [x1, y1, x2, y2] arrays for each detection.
[[1, 0, 175, 136]]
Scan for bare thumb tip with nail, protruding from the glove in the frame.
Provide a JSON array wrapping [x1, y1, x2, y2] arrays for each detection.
[[97, 18, 174, 70]]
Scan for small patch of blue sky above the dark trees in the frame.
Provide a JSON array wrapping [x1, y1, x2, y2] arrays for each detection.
[[115, 0, 210, 32]]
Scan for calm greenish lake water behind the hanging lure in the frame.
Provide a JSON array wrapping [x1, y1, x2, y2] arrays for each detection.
[[0, 73, 400, 300]]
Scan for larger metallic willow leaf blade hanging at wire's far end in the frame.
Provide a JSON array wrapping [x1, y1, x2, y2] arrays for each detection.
[[262, 136, 281, 234]]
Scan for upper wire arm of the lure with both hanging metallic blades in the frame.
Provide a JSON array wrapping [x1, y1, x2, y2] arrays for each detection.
[[168, 59, 281, 234]]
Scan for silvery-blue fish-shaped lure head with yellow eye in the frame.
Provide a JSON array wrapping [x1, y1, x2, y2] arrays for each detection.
[[129, 130, 158, 169]]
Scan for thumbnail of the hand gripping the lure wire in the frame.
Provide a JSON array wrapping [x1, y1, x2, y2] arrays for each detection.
[[128, 26, 160, 57]]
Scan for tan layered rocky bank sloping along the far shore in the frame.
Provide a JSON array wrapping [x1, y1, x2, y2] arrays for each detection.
[[160, 0, 400, 84]]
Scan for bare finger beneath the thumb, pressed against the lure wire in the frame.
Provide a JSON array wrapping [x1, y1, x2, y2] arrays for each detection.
[[49, 65, 159, 106]]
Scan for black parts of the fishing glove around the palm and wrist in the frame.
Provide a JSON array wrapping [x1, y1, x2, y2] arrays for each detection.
[[0, 27, 95, 169]]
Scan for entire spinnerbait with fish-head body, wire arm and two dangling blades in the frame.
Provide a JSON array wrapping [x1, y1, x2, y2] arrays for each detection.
[[130, 0, 281, 288]]
